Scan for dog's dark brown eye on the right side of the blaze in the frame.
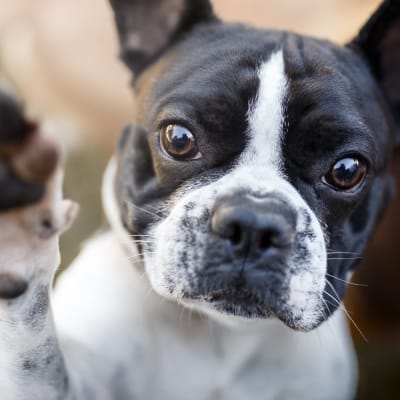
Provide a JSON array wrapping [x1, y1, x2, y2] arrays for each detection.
[[323, 157, 367, 190]]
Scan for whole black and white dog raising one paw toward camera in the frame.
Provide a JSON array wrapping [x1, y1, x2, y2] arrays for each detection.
[[0, 0, 400, 400]]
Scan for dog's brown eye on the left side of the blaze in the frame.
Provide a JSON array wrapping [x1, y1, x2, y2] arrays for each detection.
[[160, 124, 201, 160]]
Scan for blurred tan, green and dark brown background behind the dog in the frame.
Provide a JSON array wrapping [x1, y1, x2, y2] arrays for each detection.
[[0, 0, 400, 400]]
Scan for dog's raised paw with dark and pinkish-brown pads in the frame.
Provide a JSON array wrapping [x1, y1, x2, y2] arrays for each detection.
[[0, 92, 78, 300]]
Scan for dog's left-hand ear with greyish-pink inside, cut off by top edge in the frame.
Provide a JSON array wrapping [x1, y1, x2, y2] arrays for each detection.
[[110, 0, 216, 78]]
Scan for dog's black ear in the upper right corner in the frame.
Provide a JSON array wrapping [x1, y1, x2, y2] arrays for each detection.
[[348, 0, 400, 144]]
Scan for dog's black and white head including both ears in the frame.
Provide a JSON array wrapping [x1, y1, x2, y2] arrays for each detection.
[[108, 0, 400, 330]]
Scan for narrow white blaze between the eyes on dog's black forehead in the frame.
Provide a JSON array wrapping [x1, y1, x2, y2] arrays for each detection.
[[240, 50, 287, 170]]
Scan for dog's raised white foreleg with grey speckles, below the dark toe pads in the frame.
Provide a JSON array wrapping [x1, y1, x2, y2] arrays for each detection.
[[0, 176, 73, 399]]
